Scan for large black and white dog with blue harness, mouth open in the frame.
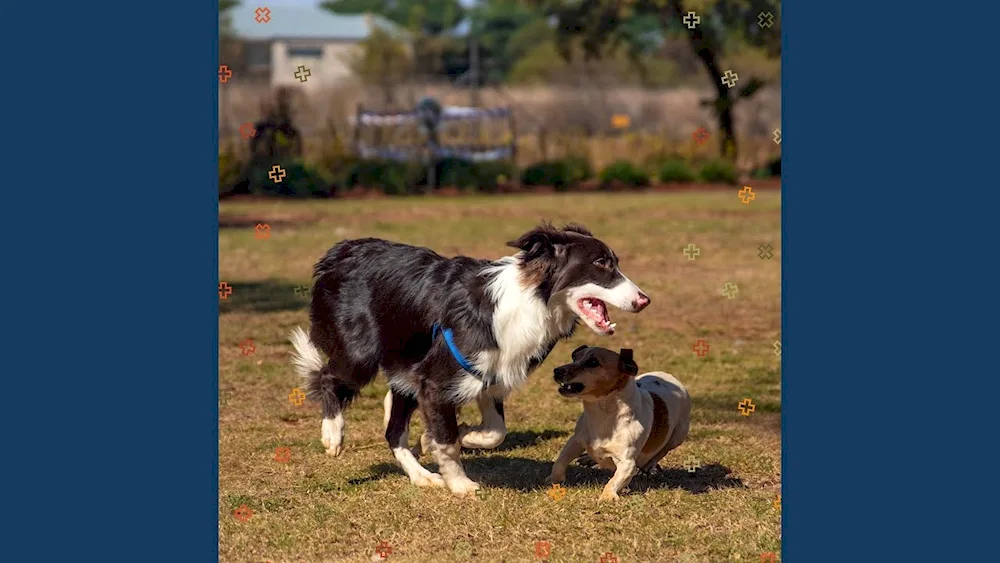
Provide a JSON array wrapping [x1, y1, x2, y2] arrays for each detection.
[[291, 224, 649, 494]]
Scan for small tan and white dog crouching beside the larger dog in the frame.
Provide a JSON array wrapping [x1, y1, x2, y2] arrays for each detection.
[[549, 346, 691, 500]]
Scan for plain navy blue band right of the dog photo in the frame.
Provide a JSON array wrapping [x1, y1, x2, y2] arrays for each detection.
[[781, 1, 1000, 563]]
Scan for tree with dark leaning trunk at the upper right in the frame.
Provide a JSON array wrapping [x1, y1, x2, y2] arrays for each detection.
[[529, 0, 781, 159]]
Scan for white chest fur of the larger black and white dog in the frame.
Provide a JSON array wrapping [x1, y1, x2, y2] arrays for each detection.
[[456, 256, 577, 402]]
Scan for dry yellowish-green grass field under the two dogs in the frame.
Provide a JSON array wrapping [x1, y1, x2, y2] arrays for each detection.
[[219, 192, 781, 563]]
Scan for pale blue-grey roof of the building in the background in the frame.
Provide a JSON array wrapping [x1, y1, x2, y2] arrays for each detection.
[[229, 6, 398, 41]]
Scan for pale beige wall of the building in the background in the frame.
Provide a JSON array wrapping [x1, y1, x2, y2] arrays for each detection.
[[271, 39, 359, 90]]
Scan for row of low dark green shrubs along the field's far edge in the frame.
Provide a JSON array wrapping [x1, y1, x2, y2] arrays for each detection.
[[219, 153, 764, 197]]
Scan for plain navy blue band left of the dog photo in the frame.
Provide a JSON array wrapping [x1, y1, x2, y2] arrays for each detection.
[[6, 0, 219, 563]]
